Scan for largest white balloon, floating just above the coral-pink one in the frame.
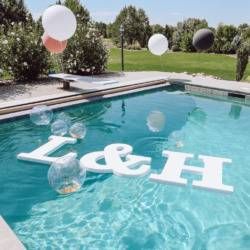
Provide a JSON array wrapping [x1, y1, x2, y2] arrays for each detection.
[[42, 5, 77, 41]]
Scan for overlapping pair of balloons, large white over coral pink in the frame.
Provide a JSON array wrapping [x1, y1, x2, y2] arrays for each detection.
[[42, 5, 77, 54]]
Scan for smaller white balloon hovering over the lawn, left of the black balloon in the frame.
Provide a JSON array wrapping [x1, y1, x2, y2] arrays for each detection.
[[148, 34, 168, 56]]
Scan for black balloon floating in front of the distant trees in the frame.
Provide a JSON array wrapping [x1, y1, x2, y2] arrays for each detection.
[[193, 29, 214, 51]]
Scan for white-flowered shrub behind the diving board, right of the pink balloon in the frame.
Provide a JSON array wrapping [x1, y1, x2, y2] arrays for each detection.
[[62, 28, 108, 75]]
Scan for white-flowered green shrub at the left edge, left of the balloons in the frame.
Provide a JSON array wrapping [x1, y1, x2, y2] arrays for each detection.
[[0, 23, 49, 81]]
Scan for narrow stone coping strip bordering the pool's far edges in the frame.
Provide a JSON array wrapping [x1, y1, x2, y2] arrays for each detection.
[[0, 73, 250, 122]]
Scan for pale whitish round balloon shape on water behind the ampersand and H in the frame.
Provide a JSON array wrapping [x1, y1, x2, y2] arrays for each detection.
[[147, 111, 166, 133]]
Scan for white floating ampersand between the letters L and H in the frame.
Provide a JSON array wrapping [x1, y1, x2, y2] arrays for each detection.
[[80, 144, 151, 177]]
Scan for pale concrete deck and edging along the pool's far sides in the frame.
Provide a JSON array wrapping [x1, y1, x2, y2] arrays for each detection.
[[0, 72, 250, 120]]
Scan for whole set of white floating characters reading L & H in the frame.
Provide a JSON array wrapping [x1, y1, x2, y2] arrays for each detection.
[[17, 136, 234, 193]]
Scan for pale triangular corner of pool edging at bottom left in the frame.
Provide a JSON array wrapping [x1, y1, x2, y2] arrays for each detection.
[[0, 216, 26, 250]]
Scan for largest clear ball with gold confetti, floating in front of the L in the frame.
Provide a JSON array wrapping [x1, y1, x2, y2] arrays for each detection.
[[48, 156, 86, 195]]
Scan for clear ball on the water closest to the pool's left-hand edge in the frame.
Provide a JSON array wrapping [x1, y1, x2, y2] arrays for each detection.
[[30, 105, 53, 126]]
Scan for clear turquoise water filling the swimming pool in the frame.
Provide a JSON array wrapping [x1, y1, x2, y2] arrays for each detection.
[[0, 85, 250, 250]]
